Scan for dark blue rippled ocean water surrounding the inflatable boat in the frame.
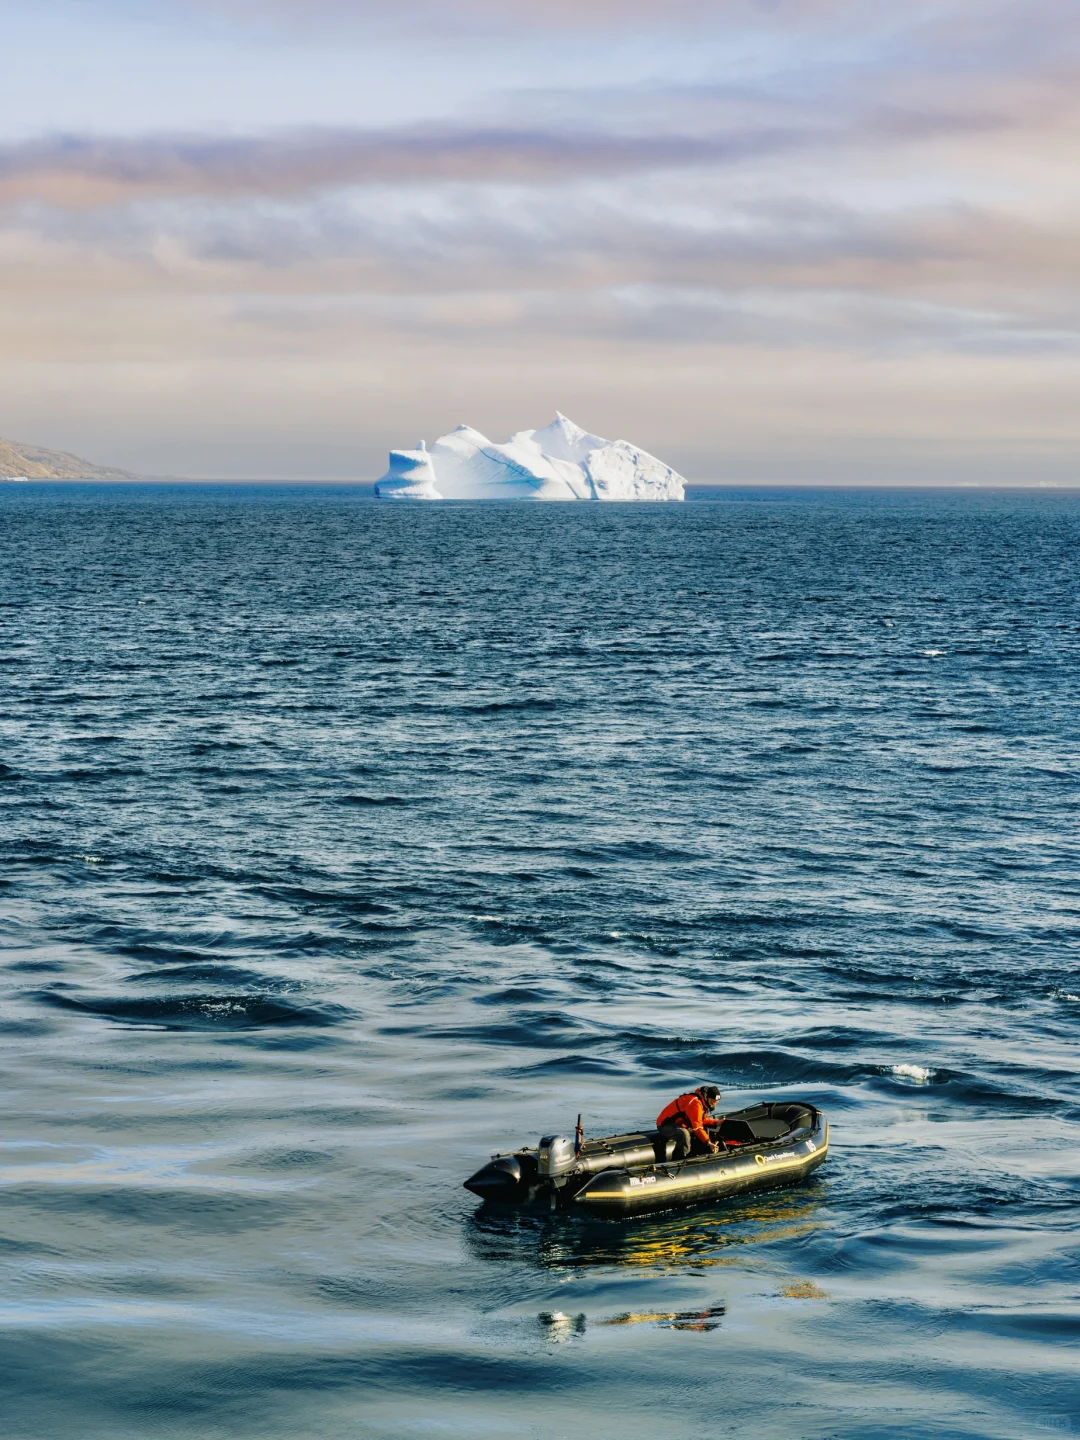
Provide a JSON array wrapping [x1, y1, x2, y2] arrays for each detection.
[[0, 484, 1080, 1440]]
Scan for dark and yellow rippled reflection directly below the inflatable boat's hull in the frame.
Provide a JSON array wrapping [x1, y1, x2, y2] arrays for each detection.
[[468, 1184, 824, 1273]]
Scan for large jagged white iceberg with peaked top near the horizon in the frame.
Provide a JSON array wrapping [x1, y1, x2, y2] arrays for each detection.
[[374, 415, 685, 500]]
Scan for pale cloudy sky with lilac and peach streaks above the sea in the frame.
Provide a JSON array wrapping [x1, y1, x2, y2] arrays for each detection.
[[0, 0, 1080, 485]]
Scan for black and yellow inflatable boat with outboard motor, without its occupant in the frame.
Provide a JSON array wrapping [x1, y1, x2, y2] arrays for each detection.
[[465, 1100, 829, 1215]]
